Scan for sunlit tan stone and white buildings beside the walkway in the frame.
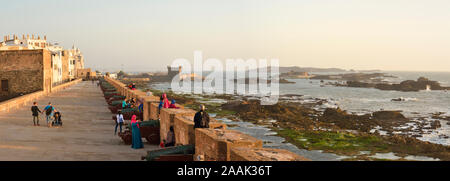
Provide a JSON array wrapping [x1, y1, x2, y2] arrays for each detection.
[[0, 35, 87, 97]]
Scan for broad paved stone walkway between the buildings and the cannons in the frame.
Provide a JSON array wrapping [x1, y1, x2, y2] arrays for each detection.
[[0, 82, 158, 161]]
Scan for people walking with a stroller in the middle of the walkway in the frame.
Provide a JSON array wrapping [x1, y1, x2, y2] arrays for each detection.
[[31, 102, 62, 127]]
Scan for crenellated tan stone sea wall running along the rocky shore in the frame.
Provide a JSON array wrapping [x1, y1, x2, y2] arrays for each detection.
[[105, 77, 308, 161]]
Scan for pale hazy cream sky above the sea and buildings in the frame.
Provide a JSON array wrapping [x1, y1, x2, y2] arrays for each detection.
[[0, 0, 450, 71]]
